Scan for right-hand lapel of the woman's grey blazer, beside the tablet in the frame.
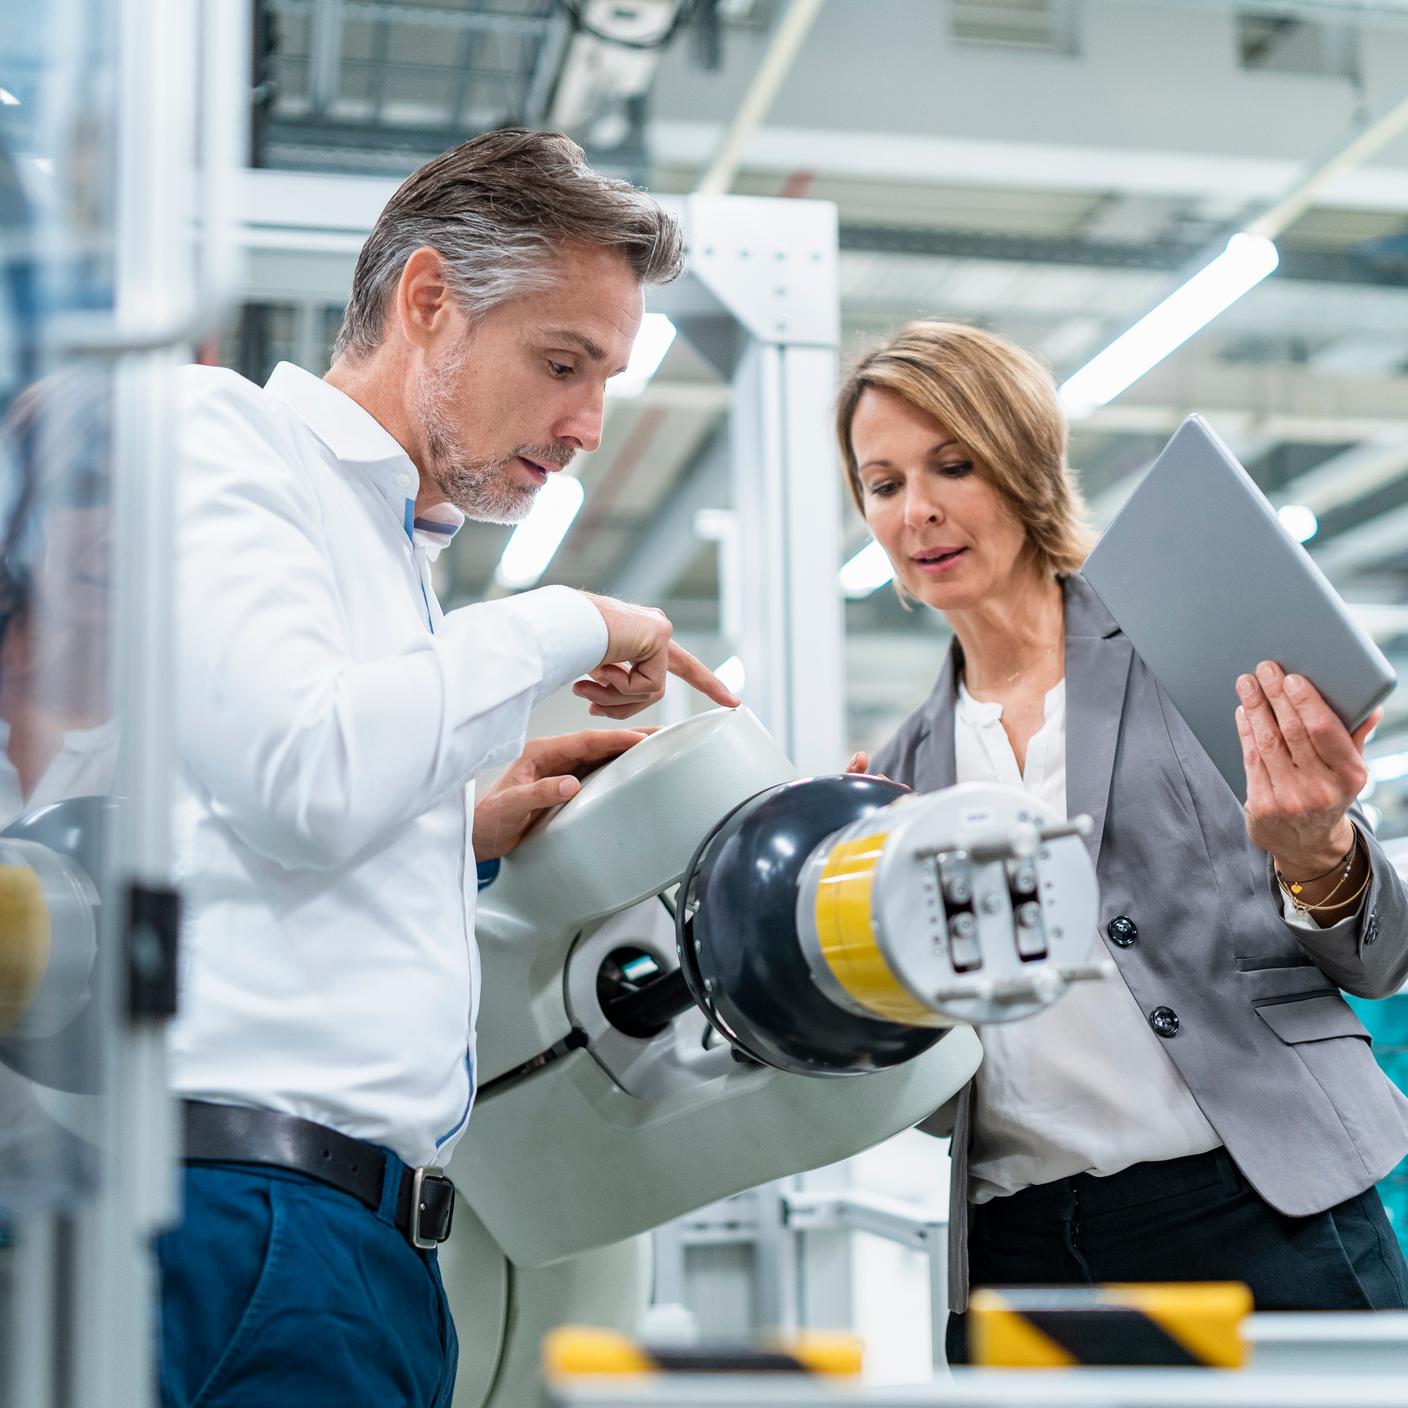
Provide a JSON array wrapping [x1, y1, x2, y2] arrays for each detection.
[[1064, 576, 1133, 866]]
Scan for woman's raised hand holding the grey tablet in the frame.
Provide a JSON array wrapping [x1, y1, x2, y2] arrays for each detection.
[[1236, 660, 1383, 879]]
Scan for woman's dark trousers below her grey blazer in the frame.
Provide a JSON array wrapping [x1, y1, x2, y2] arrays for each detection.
[[946, 1149, 1408, 1364]]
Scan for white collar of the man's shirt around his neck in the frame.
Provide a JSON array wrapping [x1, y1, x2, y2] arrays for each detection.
[[265, 362, 465, 556]]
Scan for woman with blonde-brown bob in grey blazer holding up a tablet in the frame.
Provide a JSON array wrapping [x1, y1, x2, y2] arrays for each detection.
[[838, 322, 1408, 1356]]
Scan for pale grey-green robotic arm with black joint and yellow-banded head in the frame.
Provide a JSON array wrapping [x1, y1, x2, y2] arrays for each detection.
[[442, 710, 1104, 1408]]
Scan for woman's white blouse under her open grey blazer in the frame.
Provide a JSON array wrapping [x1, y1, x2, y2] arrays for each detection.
[[953, 680, 1222, 1202]]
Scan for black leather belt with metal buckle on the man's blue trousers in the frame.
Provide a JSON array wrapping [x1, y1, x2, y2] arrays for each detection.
[[182, 1100, 455, 1249]]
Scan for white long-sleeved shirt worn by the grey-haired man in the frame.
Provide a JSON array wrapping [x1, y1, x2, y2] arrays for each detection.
[[170, 363, 607, 1164]]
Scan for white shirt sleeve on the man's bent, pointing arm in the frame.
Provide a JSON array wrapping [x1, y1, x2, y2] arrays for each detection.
[[177, 379, 607, 867]]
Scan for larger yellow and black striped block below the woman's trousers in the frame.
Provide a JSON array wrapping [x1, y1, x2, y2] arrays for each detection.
[[967, 1281, 1252, 1369]]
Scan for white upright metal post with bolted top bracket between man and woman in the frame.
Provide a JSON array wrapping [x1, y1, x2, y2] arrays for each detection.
[[683, 196, 845, 773]]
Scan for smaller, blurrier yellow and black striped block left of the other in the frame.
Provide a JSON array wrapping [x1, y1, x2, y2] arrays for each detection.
[[542, 1325, 862, 1380]]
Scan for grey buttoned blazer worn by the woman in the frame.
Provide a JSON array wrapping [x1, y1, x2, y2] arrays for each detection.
[[872, 576, 1408, 1309]]
